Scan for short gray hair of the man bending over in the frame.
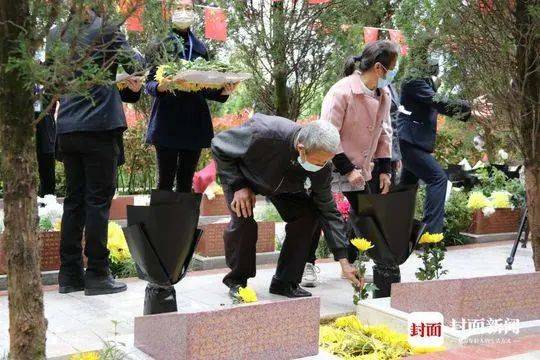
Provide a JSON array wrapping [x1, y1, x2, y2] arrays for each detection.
[[294, 120, 340, 154]]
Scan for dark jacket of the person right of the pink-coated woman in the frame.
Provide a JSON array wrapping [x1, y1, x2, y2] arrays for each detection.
[[398, 78, 471, 152]]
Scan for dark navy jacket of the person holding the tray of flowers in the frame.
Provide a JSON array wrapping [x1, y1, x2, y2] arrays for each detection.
[[146, 31, 228, 150]]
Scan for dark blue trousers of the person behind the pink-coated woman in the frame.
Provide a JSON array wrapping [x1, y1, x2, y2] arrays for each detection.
[[399, 141, 448, 234]]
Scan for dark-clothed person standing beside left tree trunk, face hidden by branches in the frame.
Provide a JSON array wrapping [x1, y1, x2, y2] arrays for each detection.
[[47, 6, 141, 295]]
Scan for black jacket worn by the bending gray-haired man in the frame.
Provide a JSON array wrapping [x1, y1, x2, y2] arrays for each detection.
[[212, 114, 347, 260]]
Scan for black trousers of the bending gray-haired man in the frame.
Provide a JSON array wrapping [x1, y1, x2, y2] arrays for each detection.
[[223, 189, 319, 287]]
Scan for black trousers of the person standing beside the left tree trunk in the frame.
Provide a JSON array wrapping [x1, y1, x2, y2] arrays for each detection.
[[58, 131, 119, 285]]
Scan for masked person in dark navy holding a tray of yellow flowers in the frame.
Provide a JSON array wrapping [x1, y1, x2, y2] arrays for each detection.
[[146, 0, 234, 192]]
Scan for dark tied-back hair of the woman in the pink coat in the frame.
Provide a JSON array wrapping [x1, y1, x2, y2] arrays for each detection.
[[344, 40, 399, 76]]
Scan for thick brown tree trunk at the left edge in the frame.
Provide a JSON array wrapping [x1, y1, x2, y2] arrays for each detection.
[[0, 0, 46, 360]]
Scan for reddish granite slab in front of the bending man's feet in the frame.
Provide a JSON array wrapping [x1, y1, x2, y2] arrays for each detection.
[[135, 297, 320, 360]]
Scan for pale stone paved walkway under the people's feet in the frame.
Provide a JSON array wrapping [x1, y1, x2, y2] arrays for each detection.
[[0, 242, 534, 358]]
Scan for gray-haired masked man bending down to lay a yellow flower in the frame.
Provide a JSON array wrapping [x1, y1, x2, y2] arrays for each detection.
[[212, 114, 361, 298]]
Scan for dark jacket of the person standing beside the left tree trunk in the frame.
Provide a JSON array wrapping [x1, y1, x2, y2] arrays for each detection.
[[47, 16, 142, 134]]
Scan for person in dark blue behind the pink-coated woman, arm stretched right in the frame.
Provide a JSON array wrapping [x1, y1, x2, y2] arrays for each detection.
[[397, 59, 487, 234]]
